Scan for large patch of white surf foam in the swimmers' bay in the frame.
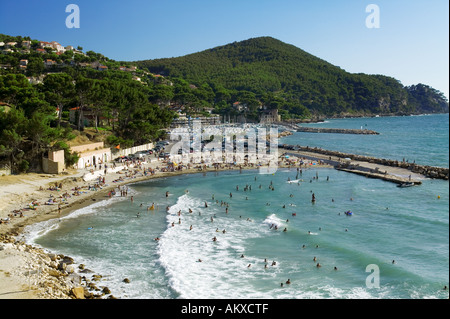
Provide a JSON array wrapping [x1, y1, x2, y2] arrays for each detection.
[[158, 195, 274, 298]]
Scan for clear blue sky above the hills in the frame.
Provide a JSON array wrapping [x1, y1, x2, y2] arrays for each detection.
[[0, 0, 449, 97]]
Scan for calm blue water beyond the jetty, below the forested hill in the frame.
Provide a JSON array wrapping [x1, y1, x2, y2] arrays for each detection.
[[280, 114, 449, 167]]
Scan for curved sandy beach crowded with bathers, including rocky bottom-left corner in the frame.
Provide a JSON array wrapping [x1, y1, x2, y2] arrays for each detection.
[[0, 150, 326, 299]]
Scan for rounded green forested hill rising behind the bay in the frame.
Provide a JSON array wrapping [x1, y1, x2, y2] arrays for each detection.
[[136, 37, 448, 117]]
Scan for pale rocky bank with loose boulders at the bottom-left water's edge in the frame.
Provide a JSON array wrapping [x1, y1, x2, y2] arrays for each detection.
[[0, 234, 119, 299]]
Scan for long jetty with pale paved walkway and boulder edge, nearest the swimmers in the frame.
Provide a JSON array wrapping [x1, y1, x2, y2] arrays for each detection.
[[278, 144, 449, 185]]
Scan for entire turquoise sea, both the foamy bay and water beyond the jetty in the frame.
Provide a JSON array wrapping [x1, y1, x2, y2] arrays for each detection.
[[26, 114, 449, 299]]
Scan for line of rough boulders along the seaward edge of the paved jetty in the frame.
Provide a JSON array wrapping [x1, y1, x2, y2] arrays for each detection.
[[279, 144, 449, 180]]
